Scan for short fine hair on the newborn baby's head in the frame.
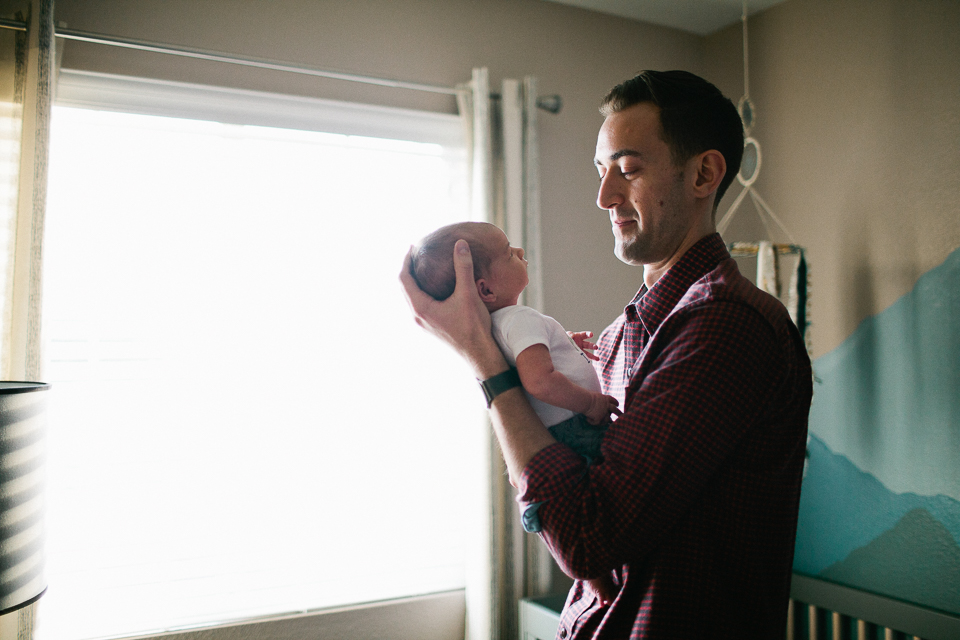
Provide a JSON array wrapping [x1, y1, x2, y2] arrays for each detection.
[[410, 222, 490, 300]]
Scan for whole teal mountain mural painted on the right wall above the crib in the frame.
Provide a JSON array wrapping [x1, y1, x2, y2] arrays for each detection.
[[794, 249, 960, 614]]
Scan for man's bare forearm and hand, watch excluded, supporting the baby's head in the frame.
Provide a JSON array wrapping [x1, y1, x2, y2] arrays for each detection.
[[400, 240, 556, 484]]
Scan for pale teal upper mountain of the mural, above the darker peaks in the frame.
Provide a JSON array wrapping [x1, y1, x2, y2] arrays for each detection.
[[810, 249, 960, 499]]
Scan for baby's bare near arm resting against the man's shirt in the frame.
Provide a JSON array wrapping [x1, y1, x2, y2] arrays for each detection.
[[517, 344, 620, 424]]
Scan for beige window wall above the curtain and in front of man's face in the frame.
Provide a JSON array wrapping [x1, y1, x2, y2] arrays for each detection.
[[50, 0, 701, 338]]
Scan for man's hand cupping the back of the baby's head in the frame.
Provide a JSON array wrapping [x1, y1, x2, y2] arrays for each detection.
[[400, 240, 508, 380]]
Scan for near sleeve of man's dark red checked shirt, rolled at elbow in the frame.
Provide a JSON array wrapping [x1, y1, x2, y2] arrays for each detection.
[[517, 301, 783, 579]]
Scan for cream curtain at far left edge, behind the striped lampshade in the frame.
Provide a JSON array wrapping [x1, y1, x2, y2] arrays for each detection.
[[0, 0, 55, 640]]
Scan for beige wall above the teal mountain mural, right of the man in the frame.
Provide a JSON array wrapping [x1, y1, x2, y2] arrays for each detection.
[[704, 0, 960, 356]]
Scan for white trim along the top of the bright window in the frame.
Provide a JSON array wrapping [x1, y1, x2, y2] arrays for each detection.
[[55, 69, 463, 146]]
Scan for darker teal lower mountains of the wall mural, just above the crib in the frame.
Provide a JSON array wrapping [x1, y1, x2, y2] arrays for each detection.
[[794, 435, 960, 614]]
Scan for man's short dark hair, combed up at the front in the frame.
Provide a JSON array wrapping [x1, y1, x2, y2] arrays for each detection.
[[600, 71, 743, 211]]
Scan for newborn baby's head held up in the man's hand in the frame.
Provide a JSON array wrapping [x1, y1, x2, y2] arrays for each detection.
[[410, 222, 528, 311]]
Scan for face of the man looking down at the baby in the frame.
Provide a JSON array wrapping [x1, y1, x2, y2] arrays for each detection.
[[595, 102, 693, 265]]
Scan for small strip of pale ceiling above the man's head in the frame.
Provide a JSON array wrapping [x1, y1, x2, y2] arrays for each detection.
[[547, 0, 784, 36]]
